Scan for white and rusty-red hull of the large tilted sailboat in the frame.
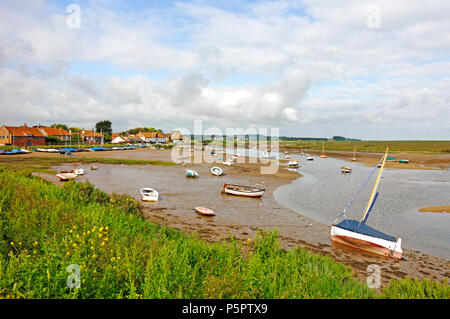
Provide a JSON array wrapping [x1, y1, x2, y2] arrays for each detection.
[[331, 226, 403, 259]]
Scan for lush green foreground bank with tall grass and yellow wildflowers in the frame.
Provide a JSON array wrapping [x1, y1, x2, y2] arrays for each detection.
[[0, 168, 449, 298]]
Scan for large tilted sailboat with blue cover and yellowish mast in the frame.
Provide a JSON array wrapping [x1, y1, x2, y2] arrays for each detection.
[[331, 148, 403, 259]]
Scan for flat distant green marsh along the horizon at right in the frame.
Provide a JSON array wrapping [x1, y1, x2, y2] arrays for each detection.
[[280, 141, 450, 153]]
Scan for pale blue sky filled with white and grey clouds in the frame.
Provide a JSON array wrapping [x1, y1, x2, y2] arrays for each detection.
[[0, 0, 450, 140]]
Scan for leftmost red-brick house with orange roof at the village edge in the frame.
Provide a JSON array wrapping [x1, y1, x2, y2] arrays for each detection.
[[0, 124, 45, 146]]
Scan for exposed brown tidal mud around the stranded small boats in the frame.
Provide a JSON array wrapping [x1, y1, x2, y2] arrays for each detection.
[[16, 150, 450, 285]]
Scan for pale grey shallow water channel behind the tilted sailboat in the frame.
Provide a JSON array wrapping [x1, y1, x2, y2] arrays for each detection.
[[274, 155, 450, 259]]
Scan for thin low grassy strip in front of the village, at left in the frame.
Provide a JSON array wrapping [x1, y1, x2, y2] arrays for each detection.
[[0, 156, 178, 174]]
